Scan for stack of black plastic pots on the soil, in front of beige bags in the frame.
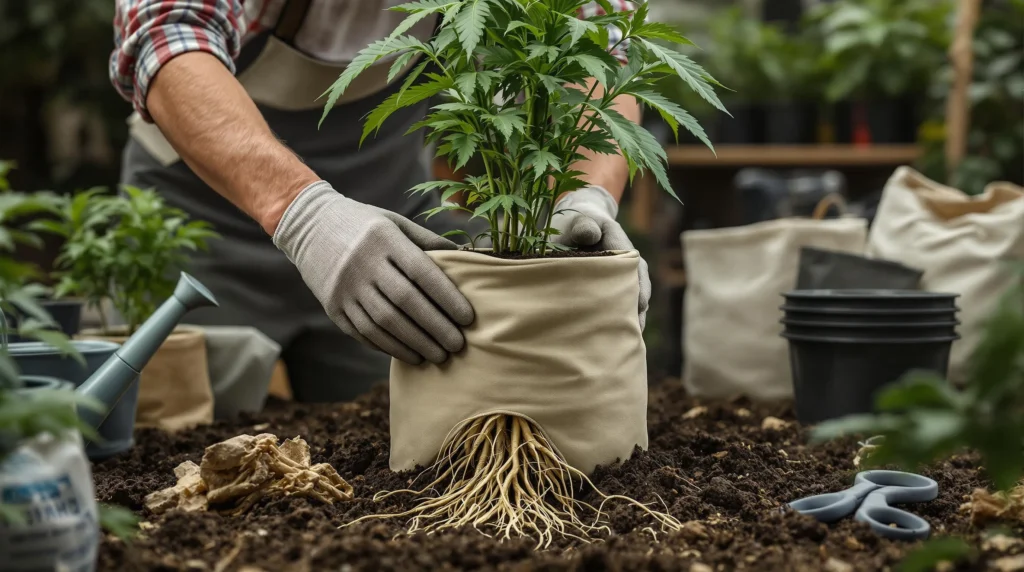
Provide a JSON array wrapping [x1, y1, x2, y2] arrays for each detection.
[[781, 290, 959, 424]]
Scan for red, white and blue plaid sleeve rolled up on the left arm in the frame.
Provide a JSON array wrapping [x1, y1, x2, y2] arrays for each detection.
[[110, 0, 244, 121]]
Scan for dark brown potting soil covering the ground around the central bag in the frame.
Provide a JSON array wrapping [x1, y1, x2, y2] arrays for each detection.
[[94, 381, 1021, 572]]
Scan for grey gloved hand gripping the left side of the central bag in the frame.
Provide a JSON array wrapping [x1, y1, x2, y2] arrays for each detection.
[[273, 181, 473, 365]]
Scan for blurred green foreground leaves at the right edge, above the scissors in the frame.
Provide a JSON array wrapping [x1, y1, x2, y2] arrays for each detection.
[[814, 268, 1024, 489]]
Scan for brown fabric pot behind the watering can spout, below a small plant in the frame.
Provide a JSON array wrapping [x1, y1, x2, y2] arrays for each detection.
[[79, 325, 213, 431]]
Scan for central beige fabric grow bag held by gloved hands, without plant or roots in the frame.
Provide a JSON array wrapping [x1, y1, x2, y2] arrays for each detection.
[[390, 251, 647, 473]]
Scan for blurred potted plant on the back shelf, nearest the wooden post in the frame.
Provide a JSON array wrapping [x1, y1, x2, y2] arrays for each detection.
[[808, 0, 952, 143]]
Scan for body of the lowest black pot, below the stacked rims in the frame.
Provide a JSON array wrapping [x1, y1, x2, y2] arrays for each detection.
[[782, 334, 958, 424]]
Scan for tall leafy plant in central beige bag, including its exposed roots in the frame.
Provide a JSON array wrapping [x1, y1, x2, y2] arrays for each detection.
[[325, 0, 723, 546]]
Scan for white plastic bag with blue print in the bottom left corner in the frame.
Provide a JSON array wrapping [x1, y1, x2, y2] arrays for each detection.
[[0, 432, 99, 572]]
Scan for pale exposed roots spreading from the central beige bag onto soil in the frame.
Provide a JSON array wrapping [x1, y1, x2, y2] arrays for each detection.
[[345, 414, 682, 548]]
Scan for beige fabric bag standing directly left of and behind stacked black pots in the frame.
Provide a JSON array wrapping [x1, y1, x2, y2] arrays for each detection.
[[682, 203, 867, 399]]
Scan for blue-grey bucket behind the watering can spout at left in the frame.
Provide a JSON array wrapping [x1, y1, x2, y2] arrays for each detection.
[[8, 340, 138, 460]]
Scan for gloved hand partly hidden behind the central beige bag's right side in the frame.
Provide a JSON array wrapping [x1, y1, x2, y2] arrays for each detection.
[[551, 186, 650, 331]]
